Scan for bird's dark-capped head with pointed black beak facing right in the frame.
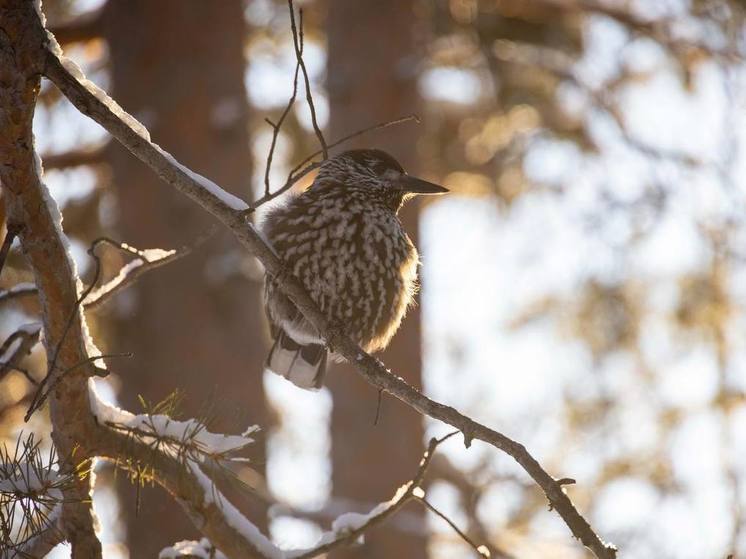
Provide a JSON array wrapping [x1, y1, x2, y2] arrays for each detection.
[[312, 149, 448, 210]]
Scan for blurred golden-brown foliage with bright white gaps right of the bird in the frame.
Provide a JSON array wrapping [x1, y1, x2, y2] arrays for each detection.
[[422, 0, 746, 557]]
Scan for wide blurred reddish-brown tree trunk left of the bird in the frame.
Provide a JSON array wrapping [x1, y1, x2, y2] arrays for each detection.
[[103, 0, 266, 557]]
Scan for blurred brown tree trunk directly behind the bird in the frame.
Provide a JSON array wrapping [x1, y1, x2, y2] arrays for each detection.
[[327, 0, 427, 559]]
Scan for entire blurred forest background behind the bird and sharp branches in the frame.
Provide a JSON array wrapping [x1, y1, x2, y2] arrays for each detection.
[[0, 0, 746, 559]]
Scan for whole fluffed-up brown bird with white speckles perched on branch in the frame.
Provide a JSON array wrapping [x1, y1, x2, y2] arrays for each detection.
[[260, 149, 448, 390]]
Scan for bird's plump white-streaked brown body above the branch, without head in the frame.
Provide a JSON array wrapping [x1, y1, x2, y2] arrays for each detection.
[[274, 200, 418, 350]]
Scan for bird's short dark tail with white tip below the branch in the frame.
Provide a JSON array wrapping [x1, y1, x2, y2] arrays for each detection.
[[265, 329, 327, 390]]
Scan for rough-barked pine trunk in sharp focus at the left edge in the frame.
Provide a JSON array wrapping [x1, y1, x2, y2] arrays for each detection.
[[0, 0, 101, 559]]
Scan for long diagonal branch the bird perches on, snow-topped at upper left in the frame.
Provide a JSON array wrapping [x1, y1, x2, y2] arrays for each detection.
[[37, 2, 616, 559]]
